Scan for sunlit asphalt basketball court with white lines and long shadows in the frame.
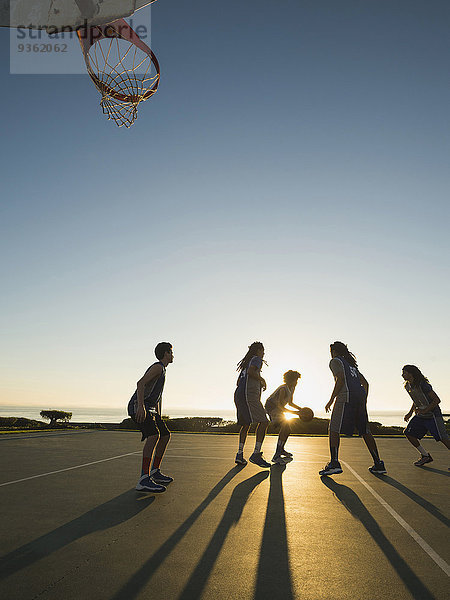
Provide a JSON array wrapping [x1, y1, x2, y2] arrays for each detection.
[[0, 431, 450, 600]]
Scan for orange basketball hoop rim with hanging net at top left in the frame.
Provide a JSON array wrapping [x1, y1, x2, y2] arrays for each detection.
[[77, 19, 160, 127]]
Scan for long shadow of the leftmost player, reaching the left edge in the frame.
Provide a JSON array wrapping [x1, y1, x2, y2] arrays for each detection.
[[0, 490, 155, 577]]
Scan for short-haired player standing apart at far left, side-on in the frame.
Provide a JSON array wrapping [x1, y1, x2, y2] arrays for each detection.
[[128, 342, 173, 493]]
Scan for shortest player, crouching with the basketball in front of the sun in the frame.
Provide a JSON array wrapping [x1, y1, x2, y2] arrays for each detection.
[[265, 371, 301, 464]]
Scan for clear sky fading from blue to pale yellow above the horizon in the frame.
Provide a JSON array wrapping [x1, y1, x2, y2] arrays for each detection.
[[0, 0, 450, 420]]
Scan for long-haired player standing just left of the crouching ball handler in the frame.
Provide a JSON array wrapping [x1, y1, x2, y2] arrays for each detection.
[[234, 342, 270, 468]]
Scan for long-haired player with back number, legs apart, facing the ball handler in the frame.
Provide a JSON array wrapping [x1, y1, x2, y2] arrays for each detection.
[[319, 342, 386, 475]]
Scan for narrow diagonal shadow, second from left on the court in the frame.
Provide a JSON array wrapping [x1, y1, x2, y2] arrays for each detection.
[[111, 467, 242, 600]]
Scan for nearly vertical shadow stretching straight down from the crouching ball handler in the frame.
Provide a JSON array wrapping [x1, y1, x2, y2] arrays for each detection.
[[254, 465, 295, 600]]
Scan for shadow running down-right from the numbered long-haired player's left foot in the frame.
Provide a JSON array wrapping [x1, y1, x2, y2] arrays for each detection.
[[322, 477, 436, 600]]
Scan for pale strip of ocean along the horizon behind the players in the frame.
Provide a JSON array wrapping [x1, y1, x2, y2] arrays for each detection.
[[0, 405, 414, 426]]
